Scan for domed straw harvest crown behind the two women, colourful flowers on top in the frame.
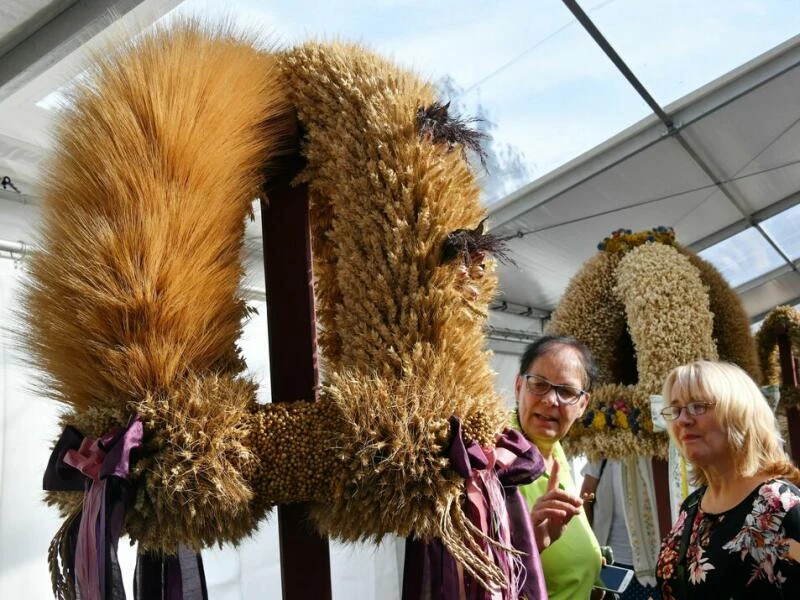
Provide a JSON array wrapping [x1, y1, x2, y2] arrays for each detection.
[[548, 227, 766, 458]]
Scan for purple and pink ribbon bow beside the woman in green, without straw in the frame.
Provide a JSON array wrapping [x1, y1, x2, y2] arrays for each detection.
[[403, 417, 547, 600]]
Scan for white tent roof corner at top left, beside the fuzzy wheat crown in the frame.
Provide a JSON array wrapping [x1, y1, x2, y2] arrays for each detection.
[[0, 0, 179, 201]]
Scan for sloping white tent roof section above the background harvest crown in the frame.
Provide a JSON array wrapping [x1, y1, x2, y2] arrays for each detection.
[[490, 36, 800, 320]]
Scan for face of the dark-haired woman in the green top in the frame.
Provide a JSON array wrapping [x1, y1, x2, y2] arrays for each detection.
[[514, 346, 589, 445]]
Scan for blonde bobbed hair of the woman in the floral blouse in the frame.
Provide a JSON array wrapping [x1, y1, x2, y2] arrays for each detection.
[[662, 360, 800, 485]]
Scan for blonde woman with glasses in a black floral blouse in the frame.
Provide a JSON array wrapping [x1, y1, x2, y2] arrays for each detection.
[[656, 361, 800, 600]]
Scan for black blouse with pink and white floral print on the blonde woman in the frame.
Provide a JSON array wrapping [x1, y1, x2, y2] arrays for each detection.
[[656, 480, 800, 600]]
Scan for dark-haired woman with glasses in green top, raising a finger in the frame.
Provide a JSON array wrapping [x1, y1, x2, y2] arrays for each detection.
[[514, 336, 602, 600]]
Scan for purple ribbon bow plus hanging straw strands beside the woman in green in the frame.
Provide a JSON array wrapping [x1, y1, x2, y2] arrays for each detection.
[[403, 417, 547, 600]]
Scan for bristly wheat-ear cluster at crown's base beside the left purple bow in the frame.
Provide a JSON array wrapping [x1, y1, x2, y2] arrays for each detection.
[[127, 375, 263, 552]]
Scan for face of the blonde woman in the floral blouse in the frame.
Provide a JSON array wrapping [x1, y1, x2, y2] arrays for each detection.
[[670, 397, 732, 469]]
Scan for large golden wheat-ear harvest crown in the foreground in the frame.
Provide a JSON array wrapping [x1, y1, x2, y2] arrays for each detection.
[[26, 26, 517, 597]]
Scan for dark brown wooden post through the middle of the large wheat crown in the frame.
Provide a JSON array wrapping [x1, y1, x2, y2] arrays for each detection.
[[261, 151, 331, 600]]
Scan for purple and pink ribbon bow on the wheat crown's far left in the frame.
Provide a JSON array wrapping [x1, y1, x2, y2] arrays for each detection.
[[43, 415, 143, 600]]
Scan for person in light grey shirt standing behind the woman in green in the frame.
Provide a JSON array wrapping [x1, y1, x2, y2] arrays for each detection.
[[581, 459, 661, 600]]
